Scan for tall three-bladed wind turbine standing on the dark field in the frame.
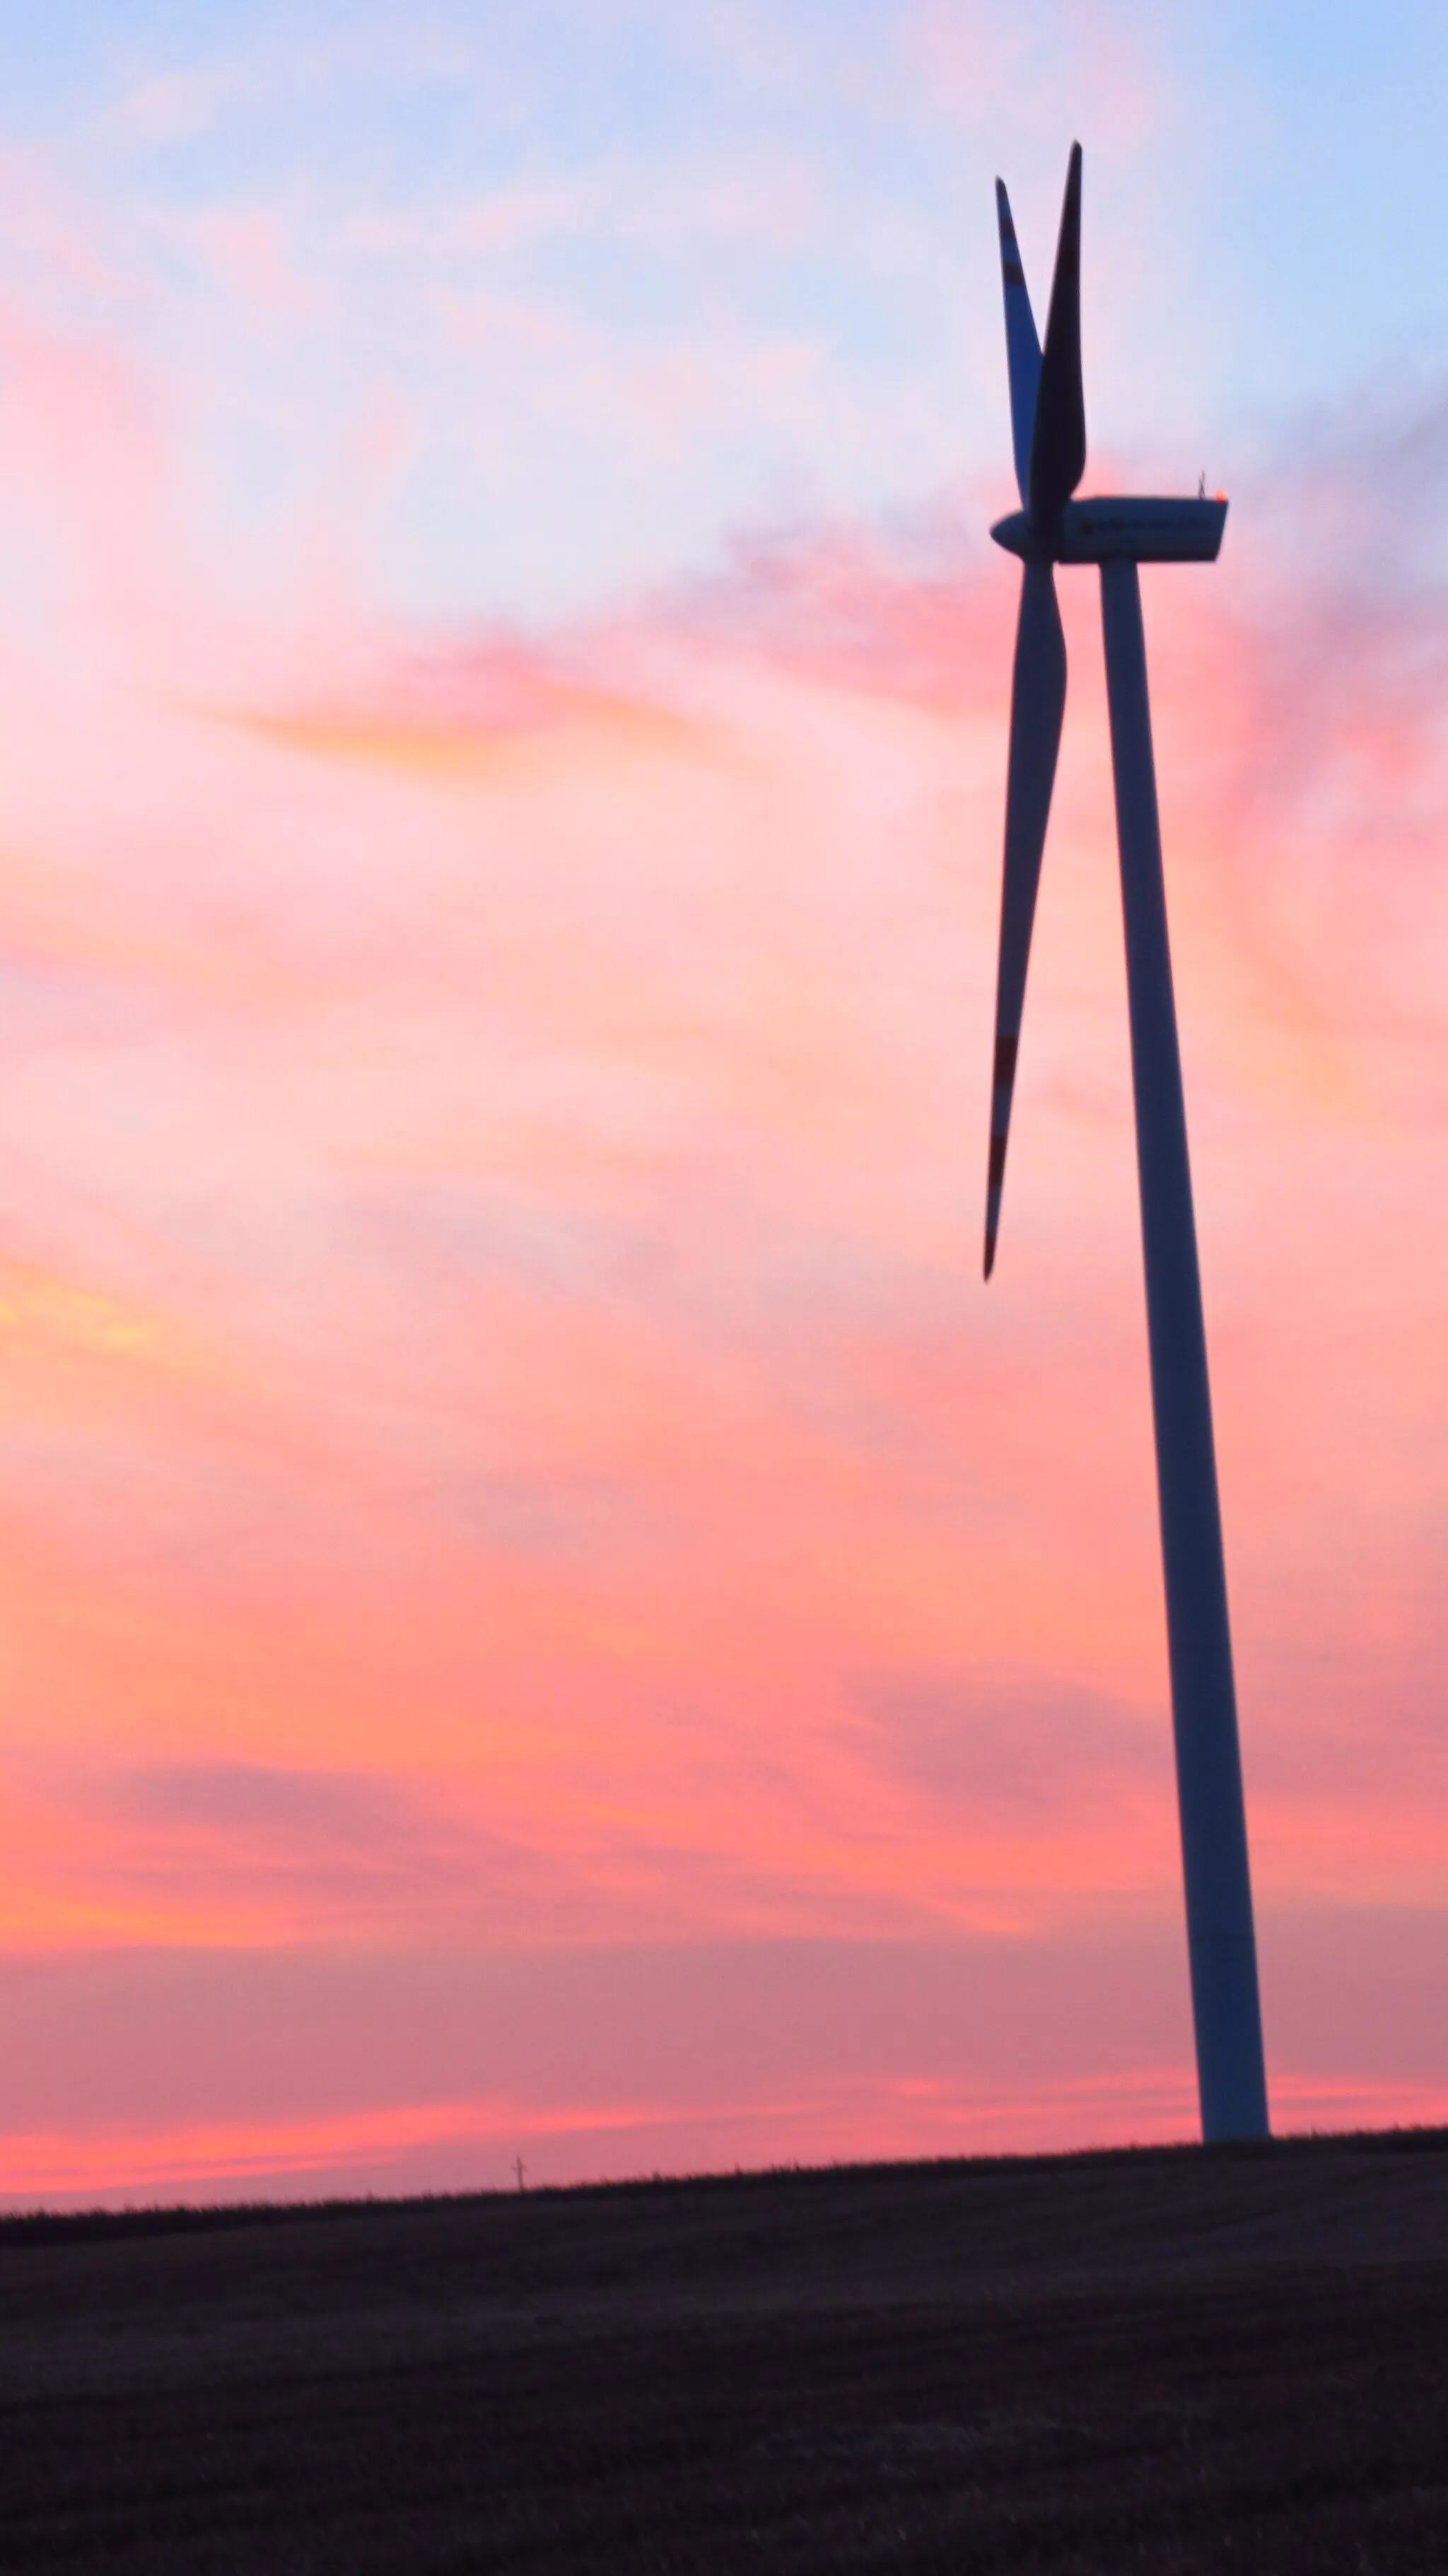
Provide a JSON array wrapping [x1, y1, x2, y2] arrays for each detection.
[[984, 144, 1268, 2141]]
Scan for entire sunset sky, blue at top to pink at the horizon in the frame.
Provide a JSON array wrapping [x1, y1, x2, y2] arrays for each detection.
[[0, 0, 1448, 2205]]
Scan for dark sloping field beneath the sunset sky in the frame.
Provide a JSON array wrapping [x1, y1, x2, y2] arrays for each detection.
[[0, 2133, 1448, 2576]]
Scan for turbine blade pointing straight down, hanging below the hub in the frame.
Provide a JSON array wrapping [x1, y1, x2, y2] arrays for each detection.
[[984, 564, 1067, 1277]]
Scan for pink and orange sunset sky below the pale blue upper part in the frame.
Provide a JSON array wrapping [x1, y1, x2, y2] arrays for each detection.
[[0, 10, 1448, 2203]]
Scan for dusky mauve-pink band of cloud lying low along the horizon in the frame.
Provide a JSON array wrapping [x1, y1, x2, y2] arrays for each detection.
[[0, 1909, 1445, 2205]]
